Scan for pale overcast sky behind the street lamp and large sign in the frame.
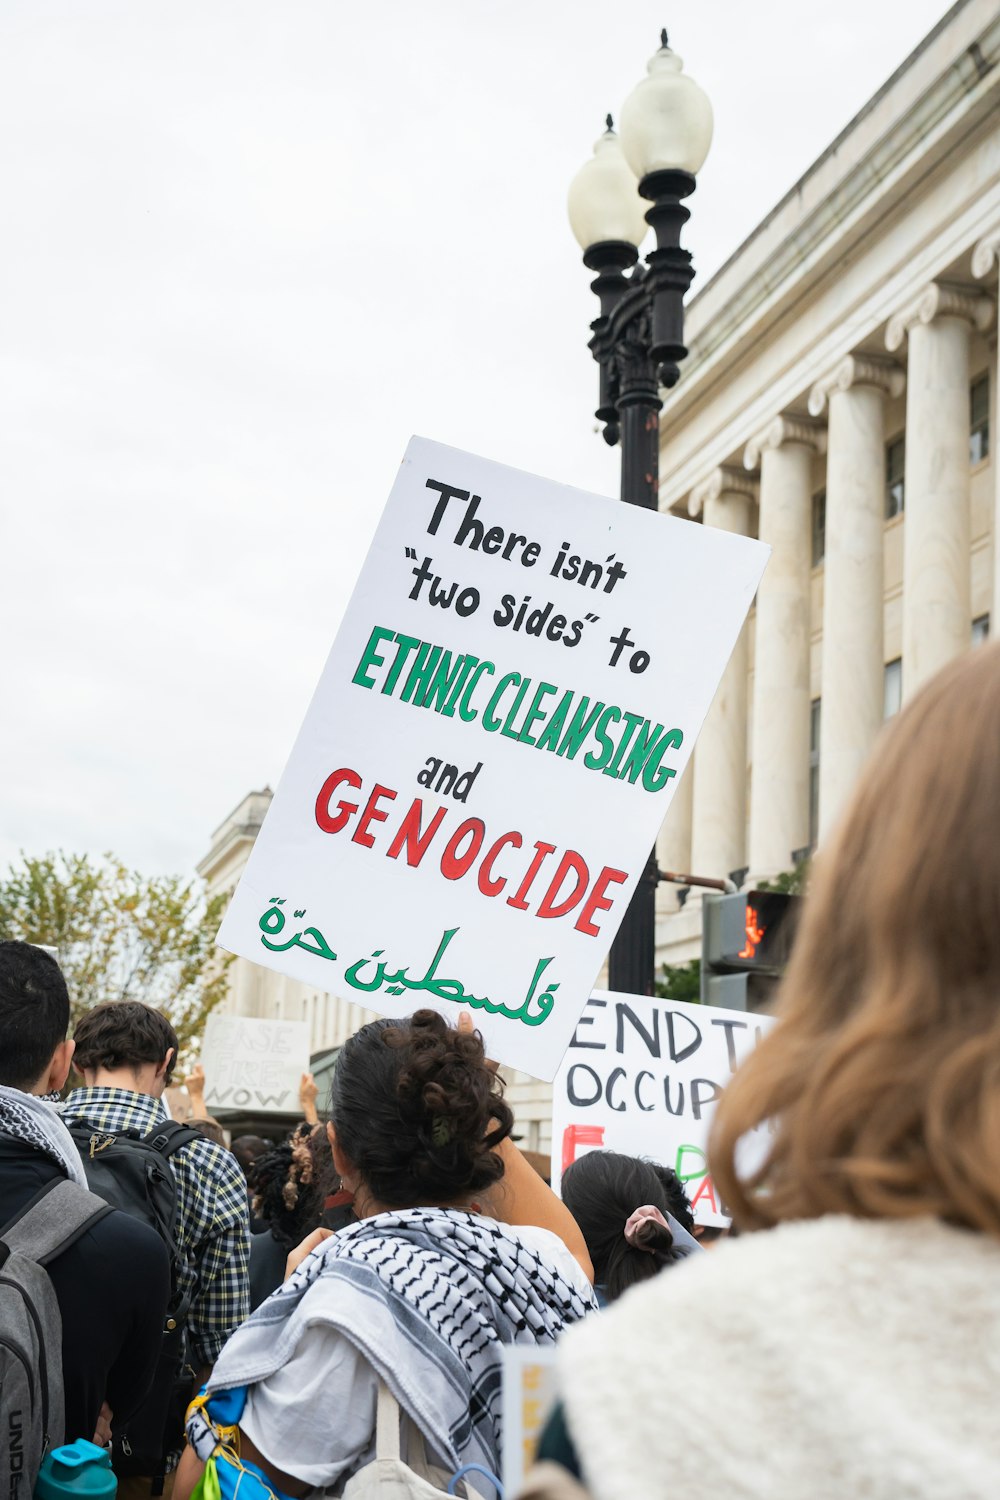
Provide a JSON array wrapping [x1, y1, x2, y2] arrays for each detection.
[[0, 0, 945, 873]]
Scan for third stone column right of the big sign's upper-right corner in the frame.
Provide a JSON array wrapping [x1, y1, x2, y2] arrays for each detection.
[[886, 282, 993, 699]]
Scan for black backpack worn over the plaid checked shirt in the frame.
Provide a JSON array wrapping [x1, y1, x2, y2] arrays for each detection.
[[66, 1119, 201, 1496]]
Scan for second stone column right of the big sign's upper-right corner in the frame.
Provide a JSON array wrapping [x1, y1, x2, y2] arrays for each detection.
[[810, 354, 904, 842]]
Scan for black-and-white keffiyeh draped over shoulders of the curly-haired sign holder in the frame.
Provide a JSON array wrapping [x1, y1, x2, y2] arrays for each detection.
[[203, 1209, 597, 1473]]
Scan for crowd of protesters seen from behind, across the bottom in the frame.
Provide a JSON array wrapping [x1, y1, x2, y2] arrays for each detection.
[[0, 645, 1000, 1500]]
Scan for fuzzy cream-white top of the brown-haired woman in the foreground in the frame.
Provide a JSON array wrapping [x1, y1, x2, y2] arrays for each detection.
[[559, 1217, 1000, 1500]]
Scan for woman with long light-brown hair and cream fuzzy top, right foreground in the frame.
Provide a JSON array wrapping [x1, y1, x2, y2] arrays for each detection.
[[535, 645, 1000, 1500]]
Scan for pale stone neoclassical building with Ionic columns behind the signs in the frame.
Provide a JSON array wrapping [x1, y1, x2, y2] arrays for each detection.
[[199, 0, 1000, 1151]]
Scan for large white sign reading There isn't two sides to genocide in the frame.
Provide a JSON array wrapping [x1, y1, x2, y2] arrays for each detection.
[[219, 438, 768, 1079]]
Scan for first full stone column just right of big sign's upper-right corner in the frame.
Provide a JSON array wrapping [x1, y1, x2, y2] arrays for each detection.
[[744, 417, 826, 879]]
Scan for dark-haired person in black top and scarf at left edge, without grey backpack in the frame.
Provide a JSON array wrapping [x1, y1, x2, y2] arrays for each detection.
[[0, 942, 169, 1442]]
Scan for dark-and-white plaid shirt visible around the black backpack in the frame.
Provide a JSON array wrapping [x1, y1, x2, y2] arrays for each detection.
[[61, 1089, 250, 1365]]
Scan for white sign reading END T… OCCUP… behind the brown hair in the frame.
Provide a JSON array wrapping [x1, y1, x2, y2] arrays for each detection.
[[552, 990, 774, 1224]]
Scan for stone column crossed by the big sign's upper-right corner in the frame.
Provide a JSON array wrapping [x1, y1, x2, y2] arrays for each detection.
[[688, 468, 757, 876]]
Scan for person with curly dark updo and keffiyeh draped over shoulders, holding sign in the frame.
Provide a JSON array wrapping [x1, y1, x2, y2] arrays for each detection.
[[174, 1011, 595, 1500]]
